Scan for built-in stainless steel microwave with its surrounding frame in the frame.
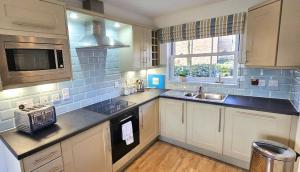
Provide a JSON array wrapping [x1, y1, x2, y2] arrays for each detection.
[[0, 35, 72, 89]]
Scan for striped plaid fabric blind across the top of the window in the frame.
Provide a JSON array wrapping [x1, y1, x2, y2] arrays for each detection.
[[158, 12, 246, 43]]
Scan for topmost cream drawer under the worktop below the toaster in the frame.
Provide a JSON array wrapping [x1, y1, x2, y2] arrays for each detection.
[[23, 144, 61, 172]]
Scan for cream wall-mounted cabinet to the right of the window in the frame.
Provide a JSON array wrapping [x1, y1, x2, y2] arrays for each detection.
[[246, 0, 300, 67]]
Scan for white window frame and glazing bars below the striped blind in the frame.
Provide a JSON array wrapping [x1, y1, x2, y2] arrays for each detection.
[[169, 34, 242, 84]]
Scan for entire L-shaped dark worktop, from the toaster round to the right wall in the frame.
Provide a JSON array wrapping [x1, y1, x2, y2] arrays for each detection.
[[1, 89, 299, 159]]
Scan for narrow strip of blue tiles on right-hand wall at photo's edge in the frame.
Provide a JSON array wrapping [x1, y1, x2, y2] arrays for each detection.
[[291, 69, 300, 111]]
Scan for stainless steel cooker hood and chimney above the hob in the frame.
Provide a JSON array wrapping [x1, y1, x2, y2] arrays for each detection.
[[78, 0, 129, 49]]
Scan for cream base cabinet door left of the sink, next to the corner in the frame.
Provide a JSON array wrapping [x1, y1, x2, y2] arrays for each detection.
[[159, 99, 186, 143]]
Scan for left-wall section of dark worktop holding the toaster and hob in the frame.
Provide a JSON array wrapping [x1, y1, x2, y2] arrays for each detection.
[[0, 89, 167, 160]]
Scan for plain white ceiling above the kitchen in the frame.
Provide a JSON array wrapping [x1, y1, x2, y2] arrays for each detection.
[[102, 0, 225, 18]]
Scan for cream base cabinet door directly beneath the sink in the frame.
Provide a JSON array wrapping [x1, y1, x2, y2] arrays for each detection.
[[187, 102, 224, 154]]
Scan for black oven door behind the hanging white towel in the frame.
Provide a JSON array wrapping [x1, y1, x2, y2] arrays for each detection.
[[110, 108, 140, 163]]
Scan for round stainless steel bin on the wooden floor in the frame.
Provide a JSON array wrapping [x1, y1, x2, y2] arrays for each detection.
[[250, 140, 297, 172]]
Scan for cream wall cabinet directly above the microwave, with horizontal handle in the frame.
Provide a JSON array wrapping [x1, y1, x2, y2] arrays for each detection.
[[0, 0, 67, 36]]
